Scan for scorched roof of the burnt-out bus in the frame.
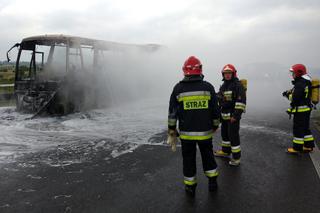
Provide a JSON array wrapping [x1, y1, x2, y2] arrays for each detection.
[[21, 34, 160, 51]]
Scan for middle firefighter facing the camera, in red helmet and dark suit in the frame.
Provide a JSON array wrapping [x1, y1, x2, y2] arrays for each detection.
[[214, 64, 246, 166]]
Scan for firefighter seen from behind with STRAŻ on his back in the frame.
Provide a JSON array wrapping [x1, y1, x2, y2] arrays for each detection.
[[168, 56, 220, 197]]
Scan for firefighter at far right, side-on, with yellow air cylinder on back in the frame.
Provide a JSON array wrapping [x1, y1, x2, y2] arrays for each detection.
[[283, 64, 314, 154]]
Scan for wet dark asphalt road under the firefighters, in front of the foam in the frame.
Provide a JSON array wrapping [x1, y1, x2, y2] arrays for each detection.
[[0, 110, 320, 213]]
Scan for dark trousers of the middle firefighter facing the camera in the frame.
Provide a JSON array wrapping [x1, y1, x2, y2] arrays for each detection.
[[221, 120, 241, 159]]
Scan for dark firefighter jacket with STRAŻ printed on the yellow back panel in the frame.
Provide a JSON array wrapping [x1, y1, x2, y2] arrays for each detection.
[[168, 75, 220, 140]]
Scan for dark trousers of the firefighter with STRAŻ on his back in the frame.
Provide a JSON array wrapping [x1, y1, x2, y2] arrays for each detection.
[[181, 138, 218, 185]]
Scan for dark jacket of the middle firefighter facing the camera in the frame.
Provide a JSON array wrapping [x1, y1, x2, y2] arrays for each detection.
[[218, 78, 246, 120]]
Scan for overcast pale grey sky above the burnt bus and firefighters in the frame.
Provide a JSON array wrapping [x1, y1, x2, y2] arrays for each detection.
[[0, 0, 320, 67]]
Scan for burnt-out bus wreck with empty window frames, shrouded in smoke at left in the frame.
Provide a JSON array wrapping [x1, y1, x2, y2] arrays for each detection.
[[7, 35, 159, 117]]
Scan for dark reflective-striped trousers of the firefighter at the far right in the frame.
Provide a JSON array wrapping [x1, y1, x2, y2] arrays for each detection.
[[292, 111, 314, 151]]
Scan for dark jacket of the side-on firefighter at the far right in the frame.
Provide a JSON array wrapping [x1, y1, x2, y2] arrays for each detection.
[[287, 75, 312, 113]]
